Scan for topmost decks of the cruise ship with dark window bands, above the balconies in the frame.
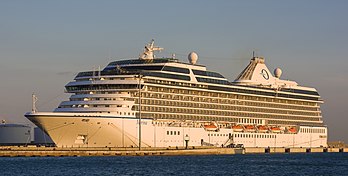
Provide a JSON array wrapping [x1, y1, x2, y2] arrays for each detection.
[[67, 55, 319, 101]]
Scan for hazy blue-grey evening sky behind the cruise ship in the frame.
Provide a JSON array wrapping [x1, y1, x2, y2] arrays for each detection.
[[0, 0, 348, 143]]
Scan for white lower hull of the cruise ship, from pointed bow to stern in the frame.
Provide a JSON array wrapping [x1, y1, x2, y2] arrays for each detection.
[[26, 113, 327, 147]]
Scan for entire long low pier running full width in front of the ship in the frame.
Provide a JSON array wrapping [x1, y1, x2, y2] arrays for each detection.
[[0, 147, 348, 157]]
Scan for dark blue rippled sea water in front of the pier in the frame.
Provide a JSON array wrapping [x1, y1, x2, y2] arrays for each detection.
[[0, 153, 348, 176]]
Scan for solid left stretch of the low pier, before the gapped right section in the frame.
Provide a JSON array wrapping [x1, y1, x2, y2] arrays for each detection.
[[0, 147, 244, 157]]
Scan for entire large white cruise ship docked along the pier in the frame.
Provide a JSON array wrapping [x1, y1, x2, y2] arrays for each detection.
[[25, 40, 327, 148]]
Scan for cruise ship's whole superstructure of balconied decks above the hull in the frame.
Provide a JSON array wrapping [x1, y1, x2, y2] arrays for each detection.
[[56, 40, 322, 125]]
